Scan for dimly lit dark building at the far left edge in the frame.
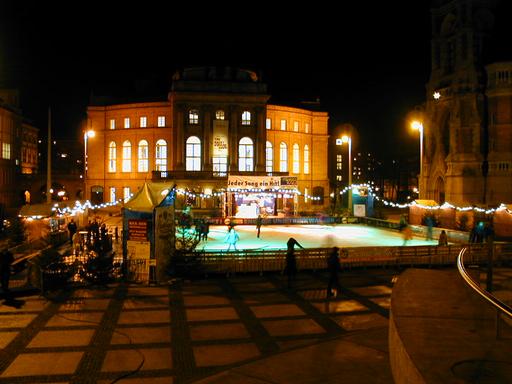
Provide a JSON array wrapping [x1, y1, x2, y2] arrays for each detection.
[[0, 89, 38, 219]]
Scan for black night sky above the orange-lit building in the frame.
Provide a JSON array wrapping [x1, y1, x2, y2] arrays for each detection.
[[0, 0, 512, 160]]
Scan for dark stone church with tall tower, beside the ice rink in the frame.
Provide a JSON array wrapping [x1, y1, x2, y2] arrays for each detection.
[[420, 0, 512, 206]]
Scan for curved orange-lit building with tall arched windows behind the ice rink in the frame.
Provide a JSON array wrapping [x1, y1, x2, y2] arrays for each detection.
[[86, 67, 329, 217]]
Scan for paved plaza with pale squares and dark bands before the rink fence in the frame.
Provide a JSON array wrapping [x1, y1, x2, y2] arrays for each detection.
[[0, 269, 398, 384]]
